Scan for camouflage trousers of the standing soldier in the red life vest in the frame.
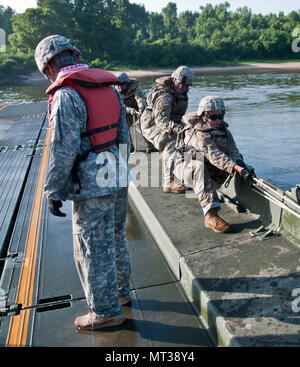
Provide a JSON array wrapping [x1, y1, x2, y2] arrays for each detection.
[[72, 188, 130, 316]]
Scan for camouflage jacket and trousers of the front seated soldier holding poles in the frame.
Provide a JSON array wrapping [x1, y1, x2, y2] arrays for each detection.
[[174, 112, 243, 214]]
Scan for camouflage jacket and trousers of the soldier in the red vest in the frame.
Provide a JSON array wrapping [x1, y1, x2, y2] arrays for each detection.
[[44, 76, 130, 316]]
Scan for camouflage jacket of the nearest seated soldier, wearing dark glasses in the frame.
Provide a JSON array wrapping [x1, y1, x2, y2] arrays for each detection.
[[176, 112, 243, 173]]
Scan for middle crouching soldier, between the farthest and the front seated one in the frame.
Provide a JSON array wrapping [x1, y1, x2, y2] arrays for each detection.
[[141, 66, 194, 194]]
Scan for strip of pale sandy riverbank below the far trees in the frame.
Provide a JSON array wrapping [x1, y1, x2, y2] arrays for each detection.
[[22, 62, 300, 85]]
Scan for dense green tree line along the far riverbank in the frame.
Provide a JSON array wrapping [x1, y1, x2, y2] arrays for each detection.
[[0, 0, 300, 80]]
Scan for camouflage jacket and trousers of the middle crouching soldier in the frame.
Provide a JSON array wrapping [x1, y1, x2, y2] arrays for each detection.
[[141, 77, 188, 186]]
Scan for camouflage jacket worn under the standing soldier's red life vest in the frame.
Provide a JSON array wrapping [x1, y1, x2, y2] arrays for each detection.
[[44, 87, 130, 200]]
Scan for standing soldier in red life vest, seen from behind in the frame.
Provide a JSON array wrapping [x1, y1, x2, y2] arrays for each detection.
[[35, 35, 130, 330]]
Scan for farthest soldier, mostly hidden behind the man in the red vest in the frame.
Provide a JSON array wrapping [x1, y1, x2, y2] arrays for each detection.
[[113, 72, 155, 154]]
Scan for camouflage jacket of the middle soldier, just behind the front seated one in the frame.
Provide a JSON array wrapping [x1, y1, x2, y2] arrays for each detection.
[[141, 77, 188, 149]]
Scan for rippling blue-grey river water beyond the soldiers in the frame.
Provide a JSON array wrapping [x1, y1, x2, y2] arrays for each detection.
[[0, 70, 300, 190]]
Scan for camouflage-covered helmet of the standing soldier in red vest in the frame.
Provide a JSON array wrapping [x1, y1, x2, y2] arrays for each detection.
[[34, 34, 81, 78]]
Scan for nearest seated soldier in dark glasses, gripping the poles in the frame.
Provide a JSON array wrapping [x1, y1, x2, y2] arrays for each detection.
[[174, 96, 254, 233]]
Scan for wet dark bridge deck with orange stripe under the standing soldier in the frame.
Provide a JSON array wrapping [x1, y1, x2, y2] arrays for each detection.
[[0, 104, 212, 347]]
